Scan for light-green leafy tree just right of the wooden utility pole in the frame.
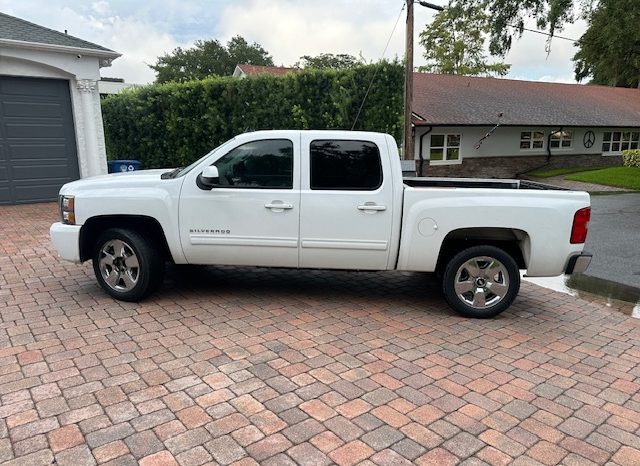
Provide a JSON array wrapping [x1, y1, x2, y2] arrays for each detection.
[[420, 0, 511, 76]]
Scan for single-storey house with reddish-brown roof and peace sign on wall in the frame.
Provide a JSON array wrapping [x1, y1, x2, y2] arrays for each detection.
[[412, 73, 640, 178]]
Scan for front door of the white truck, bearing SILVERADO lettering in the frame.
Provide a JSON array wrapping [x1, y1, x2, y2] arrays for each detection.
[[179, 133, 300, 267]]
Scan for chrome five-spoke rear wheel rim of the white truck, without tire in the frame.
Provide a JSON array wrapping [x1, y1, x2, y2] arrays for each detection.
[[454, 256, 509, 309]]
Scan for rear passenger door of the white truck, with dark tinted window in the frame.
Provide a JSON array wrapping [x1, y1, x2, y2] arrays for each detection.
[[300, 132, 394, 270]]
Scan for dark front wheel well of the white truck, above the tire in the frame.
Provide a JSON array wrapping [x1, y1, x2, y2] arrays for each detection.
[[80, 215, 173, 261]]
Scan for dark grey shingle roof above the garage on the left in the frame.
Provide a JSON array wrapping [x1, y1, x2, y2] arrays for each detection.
[[0, 13, 119, 57]]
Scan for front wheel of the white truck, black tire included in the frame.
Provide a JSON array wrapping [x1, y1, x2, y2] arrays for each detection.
[[93, 228, 165, 302]]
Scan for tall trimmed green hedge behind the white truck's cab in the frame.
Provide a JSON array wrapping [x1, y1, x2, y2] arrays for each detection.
[[102, 62, 403, 168]]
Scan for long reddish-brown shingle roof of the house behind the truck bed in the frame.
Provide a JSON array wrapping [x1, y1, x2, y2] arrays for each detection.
[[412, 73, 640, 127]]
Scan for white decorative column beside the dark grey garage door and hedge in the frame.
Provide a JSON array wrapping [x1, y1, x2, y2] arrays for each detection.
[[76, 79, 106, 176]]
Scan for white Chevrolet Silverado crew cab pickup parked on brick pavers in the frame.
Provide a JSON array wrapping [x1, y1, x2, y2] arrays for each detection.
[[51, 131, 591, 317]]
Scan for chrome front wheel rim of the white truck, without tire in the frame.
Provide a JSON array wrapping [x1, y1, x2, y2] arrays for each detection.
[[99, 239, 140, 292]]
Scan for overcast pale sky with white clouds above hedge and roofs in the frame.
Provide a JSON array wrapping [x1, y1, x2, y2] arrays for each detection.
[[0, 0, 586, 83]]
